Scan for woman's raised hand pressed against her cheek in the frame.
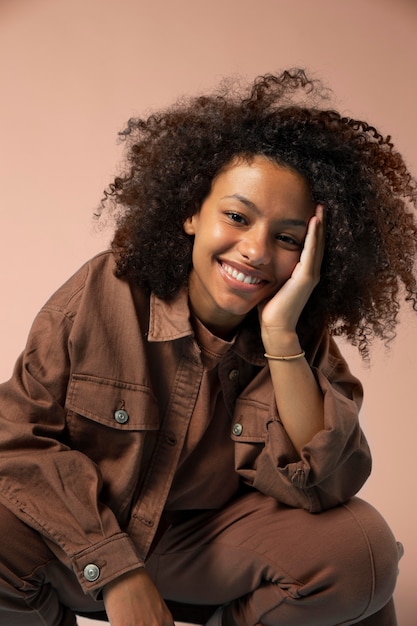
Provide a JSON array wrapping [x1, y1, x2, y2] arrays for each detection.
[[259, 204, 325, 354]]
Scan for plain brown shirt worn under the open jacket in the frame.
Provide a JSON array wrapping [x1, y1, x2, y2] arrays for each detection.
[[165, 317, 259, 510]]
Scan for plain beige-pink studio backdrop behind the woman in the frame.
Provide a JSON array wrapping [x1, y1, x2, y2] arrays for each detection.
[[0, 0, 417, 626]]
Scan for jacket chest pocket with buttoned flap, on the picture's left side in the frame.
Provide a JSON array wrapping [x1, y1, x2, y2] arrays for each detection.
[[65, 374, 159, 520]]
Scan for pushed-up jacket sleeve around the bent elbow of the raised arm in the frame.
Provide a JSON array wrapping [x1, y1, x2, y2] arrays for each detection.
[[234, 333, 371, 513]]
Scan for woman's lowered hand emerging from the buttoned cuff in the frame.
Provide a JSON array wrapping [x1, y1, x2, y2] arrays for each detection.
[[103, 568, 174, 626]]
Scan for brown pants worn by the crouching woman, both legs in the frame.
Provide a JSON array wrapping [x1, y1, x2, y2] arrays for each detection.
[[0, 493, 401, 626]]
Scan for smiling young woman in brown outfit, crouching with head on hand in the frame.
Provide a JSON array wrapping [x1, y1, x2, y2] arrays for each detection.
[[0, 70, 417, 626]]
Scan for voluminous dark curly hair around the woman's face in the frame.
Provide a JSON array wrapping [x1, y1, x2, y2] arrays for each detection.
[[101, 69, 417, 357]]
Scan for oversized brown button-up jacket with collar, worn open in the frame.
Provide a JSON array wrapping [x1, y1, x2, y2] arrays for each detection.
[[0, 252, 371, 595]]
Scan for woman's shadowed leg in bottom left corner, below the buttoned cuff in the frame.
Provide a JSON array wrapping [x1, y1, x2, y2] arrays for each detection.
[[0, 504, 103, 626]]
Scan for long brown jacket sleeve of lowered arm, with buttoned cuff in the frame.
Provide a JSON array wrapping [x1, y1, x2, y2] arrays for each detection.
[[0, 294, 143, 595]]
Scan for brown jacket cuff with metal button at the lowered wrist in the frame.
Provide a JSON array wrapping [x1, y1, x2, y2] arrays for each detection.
[[72, 533, 144, 599]]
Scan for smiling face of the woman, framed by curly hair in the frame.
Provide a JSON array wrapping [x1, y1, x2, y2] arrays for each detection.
[[184, 156, 315, 337]]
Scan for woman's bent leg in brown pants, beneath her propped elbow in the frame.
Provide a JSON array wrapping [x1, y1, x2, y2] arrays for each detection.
[[146, 492, 399, 626]]
